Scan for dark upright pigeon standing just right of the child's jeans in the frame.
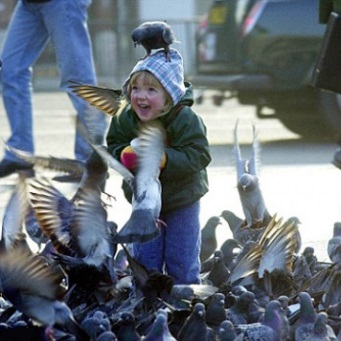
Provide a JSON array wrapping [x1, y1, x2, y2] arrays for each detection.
[[200, 216, 221, 262]]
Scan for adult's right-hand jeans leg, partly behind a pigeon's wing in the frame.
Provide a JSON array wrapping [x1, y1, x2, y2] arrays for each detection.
[[43, 0, 107, 160]]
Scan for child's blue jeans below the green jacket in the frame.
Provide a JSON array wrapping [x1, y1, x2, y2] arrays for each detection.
[[133, 201, 201, 284]]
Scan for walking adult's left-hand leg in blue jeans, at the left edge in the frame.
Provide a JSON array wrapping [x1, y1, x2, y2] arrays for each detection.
[[1, 1, 48, 161]]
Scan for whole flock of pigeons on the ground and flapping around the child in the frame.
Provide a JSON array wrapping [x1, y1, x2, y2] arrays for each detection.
[[0, 19, 341, 341]]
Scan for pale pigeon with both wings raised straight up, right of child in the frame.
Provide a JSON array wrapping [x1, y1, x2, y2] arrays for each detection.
[[233, 121, 270, 228]]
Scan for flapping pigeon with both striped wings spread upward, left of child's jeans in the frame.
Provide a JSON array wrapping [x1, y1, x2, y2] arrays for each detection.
[[29, 178, 117, 300]]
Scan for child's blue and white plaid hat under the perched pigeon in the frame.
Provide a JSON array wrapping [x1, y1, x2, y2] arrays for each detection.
[[123, 49, 186, 105]]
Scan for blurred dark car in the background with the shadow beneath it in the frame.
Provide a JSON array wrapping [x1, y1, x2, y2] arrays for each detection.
[[188, 0, 341, 138]]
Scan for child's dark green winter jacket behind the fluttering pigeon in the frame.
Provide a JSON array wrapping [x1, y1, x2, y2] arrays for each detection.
[[106, 82, 211, 212]]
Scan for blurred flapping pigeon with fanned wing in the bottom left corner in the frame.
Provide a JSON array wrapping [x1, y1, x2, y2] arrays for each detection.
[[0, 250, 90, 340]]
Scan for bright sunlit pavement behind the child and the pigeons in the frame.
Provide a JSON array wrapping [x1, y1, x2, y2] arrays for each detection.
[[0, 93, 341, 259]]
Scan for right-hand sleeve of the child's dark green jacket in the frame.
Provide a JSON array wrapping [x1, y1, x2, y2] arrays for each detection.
[[161, 106, 211, 179]]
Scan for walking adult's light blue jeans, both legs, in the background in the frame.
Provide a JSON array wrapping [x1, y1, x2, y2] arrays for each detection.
[[1, 0, 106, 160]]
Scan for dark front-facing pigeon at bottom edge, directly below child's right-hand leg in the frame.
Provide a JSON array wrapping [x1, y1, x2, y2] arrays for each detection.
[[176, 302, 209, 341]]
